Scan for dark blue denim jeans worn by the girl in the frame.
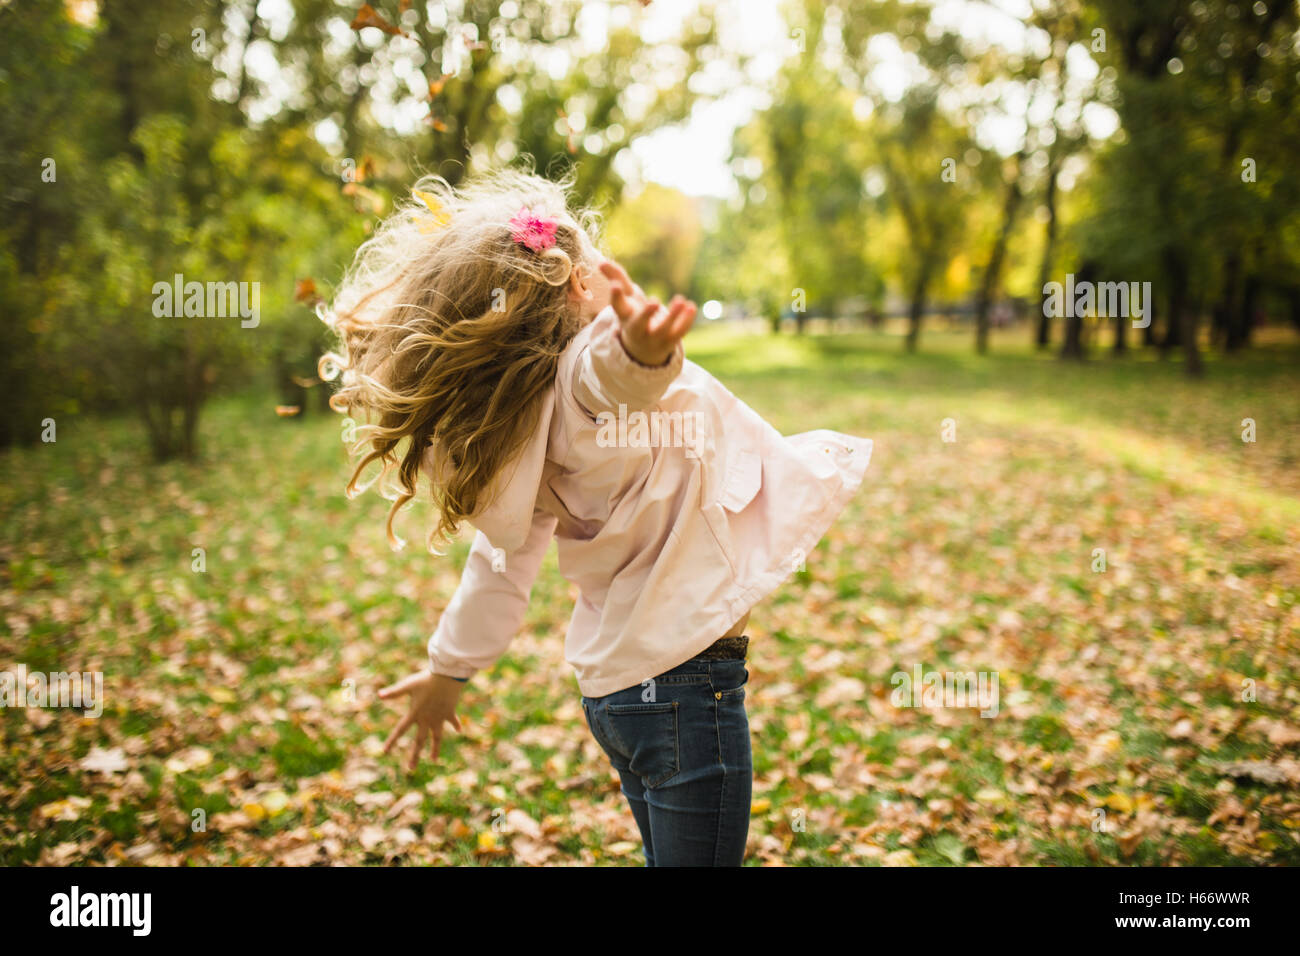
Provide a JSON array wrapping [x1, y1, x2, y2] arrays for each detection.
[[582, 659, 754, 866]]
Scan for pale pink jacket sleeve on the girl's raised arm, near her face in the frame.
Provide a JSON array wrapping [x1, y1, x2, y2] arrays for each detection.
[[572, 307, 685, 418]]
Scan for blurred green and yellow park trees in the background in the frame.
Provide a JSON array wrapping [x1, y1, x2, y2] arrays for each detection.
[[0, 0, 1300, 458]]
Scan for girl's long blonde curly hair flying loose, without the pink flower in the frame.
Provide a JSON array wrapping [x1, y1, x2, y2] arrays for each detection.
[[319, 170, 601, 553]]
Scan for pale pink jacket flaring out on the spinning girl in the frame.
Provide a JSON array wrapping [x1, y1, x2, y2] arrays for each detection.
[[426, 308, 871, 697]]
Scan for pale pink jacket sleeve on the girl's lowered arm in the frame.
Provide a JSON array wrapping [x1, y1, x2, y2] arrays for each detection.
[[429, 510, 555, 679]]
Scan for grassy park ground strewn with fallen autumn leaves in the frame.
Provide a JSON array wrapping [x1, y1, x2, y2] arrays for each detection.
[[0, 328, 1300, 865]]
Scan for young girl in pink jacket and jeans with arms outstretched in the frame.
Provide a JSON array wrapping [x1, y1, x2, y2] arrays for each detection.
[[321, 172, 871, 866]]
